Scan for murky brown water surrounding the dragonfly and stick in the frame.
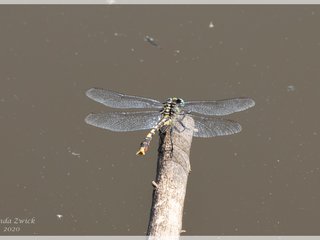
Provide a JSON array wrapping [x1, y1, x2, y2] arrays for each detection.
[[0, 5, 320, 235]]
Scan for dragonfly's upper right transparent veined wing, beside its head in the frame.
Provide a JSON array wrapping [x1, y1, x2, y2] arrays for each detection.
[[184, 98, 255, 116]]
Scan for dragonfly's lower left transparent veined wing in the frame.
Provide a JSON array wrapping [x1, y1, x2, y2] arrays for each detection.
[[85, 111, 161, 132]]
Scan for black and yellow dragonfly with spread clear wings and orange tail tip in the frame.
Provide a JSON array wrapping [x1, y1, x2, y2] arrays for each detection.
[[85, 88, 255, 155]]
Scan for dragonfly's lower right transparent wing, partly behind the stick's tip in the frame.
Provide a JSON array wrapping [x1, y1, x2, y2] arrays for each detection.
[[190, 114, 241, 138]]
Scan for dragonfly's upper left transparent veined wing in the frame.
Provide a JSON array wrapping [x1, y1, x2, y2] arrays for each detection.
[[86, 88, 162, 108]]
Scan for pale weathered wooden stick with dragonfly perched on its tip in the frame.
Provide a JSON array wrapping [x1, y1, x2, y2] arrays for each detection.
[[147, 115, 194, 240]]
